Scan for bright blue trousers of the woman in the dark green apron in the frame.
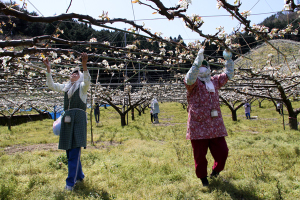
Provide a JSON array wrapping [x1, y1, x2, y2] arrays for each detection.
[[66, 147, 84, 187]]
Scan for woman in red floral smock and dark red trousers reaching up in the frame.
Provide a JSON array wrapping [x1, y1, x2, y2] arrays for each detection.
[[184, 48, 234, 186]]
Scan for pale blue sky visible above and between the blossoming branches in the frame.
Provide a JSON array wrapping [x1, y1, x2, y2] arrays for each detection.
[[2, 0, 292, 43]]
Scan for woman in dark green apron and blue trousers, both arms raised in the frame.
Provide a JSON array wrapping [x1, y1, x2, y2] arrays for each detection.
[[43, 53, 91, 191]]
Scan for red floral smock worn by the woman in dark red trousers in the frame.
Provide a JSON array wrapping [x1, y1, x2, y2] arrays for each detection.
[[185, 73, 228, 140]]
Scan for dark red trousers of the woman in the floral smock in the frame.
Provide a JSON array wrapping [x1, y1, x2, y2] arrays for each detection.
[[191, 137, 228, 178]]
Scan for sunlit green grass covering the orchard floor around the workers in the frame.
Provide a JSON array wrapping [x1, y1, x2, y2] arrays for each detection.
[[0, 101, 300, 200]]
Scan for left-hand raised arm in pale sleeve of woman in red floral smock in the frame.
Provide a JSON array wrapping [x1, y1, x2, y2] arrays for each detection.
[[185, 49, 204, 85]]
